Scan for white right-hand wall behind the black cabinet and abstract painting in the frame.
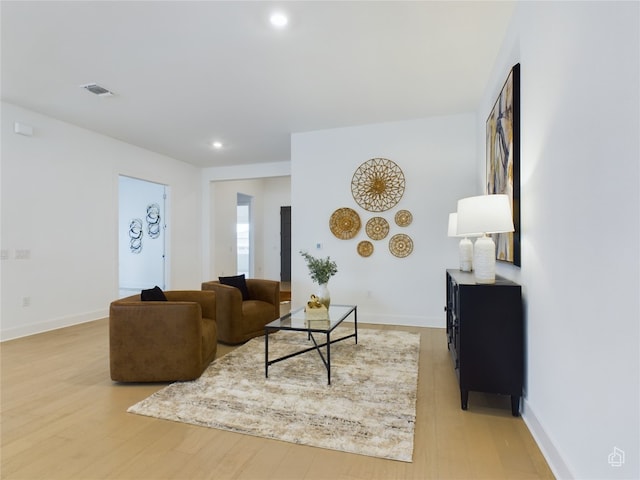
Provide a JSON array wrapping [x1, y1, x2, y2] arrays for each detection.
[[477, 2, 640, 479]]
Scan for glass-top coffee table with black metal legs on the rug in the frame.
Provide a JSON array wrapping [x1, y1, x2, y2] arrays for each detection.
[[264, 305, 358, 385]]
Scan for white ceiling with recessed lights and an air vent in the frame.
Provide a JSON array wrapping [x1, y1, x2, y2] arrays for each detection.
[[0, 1, 513, 167]]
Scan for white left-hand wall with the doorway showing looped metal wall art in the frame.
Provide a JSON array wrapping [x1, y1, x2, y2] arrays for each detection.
[[0, 103, 201, 340]]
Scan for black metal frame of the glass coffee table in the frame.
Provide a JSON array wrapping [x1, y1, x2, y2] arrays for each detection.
[[264, 305, 358, 385]]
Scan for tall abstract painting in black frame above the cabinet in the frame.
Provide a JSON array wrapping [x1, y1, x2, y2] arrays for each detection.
[[486, 63, 521, 266]]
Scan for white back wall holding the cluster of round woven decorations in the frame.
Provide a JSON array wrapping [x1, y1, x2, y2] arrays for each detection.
[[291, 114, 477, 327]]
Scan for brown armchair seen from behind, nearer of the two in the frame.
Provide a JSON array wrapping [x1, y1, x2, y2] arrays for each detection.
[[109, 290, 218, 382]]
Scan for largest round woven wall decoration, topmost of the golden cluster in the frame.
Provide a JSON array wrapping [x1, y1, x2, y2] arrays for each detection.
[[351, 158, 405, 212]]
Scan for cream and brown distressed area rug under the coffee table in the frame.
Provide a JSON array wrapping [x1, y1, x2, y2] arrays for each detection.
[[128, 325, 420, 462]]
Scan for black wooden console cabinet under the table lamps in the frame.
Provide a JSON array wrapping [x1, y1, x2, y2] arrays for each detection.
[[445, 270, 524, 416]]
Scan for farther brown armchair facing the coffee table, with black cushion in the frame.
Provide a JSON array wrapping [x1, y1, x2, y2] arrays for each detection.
[[202, 278, 280, 345]]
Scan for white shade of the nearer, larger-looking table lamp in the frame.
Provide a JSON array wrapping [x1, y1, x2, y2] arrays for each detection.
[[457, 195, 514, 235]]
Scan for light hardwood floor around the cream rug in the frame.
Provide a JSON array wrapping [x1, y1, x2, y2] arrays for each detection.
[[0, 319, 553, 480]]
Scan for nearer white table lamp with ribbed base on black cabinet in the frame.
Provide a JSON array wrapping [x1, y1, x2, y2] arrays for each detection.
[[457, 195, 514, 283]]
